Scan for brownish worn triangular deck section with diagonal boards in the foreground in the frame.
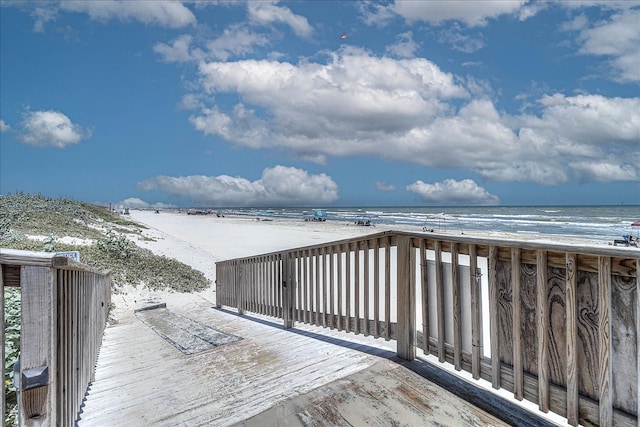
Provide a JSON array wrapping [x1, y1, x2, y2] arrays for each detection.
[[239, 360, 506, 427]]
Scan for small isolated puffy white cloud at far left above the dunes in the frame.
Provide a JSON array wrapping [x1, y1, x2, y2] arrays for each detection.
[[19, 110, 91, 148]]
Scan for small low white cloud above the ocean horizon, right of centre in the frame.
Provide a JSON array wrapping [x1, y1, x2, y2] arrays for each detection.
[[406, 179, 500, 205]]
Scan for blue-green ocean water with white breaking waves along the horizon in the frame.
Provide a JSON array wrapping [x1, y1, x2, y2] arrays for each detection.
[[221, 205, 640, 241]]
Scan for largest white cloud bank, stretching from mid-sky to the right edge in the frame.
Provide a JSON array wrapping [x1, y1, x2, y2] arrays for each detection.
[[176, 35, 640, 185]]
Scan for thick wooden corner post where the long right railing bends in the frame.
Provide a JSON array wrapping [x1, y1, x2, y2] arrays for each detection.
[[396, 236, 416, 360]]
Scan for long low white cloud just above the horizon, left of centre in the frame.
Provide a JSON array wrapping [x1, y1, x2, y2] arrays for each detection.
[[138, 165, 338, 206]]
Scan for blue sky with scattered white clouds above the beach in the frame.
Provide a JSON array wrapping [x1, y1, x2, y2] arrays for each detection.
[[0, 0, 640, 207]]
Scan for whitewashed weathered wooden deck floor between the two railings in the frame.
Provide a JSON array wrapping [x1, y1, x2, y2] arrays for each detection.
[[78, 300, 556, 427]]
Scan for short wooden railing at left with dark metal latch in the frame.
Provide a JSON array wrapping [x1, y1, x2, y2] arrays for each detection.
[[0, 249, 111, 426]]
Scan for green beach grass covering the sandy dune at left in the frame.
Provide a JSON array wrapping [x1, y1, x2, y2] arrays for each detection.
[[0, 193, 210, 426]]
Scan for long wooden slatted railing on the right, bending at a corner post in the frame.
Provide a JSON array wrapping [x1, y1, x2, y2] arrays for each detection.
[[216, 232, 640, 426]]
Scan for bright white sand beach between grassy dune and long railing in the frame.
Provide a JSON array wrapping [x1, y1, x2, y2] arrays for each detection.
[[115, 210, 603, 317]]
